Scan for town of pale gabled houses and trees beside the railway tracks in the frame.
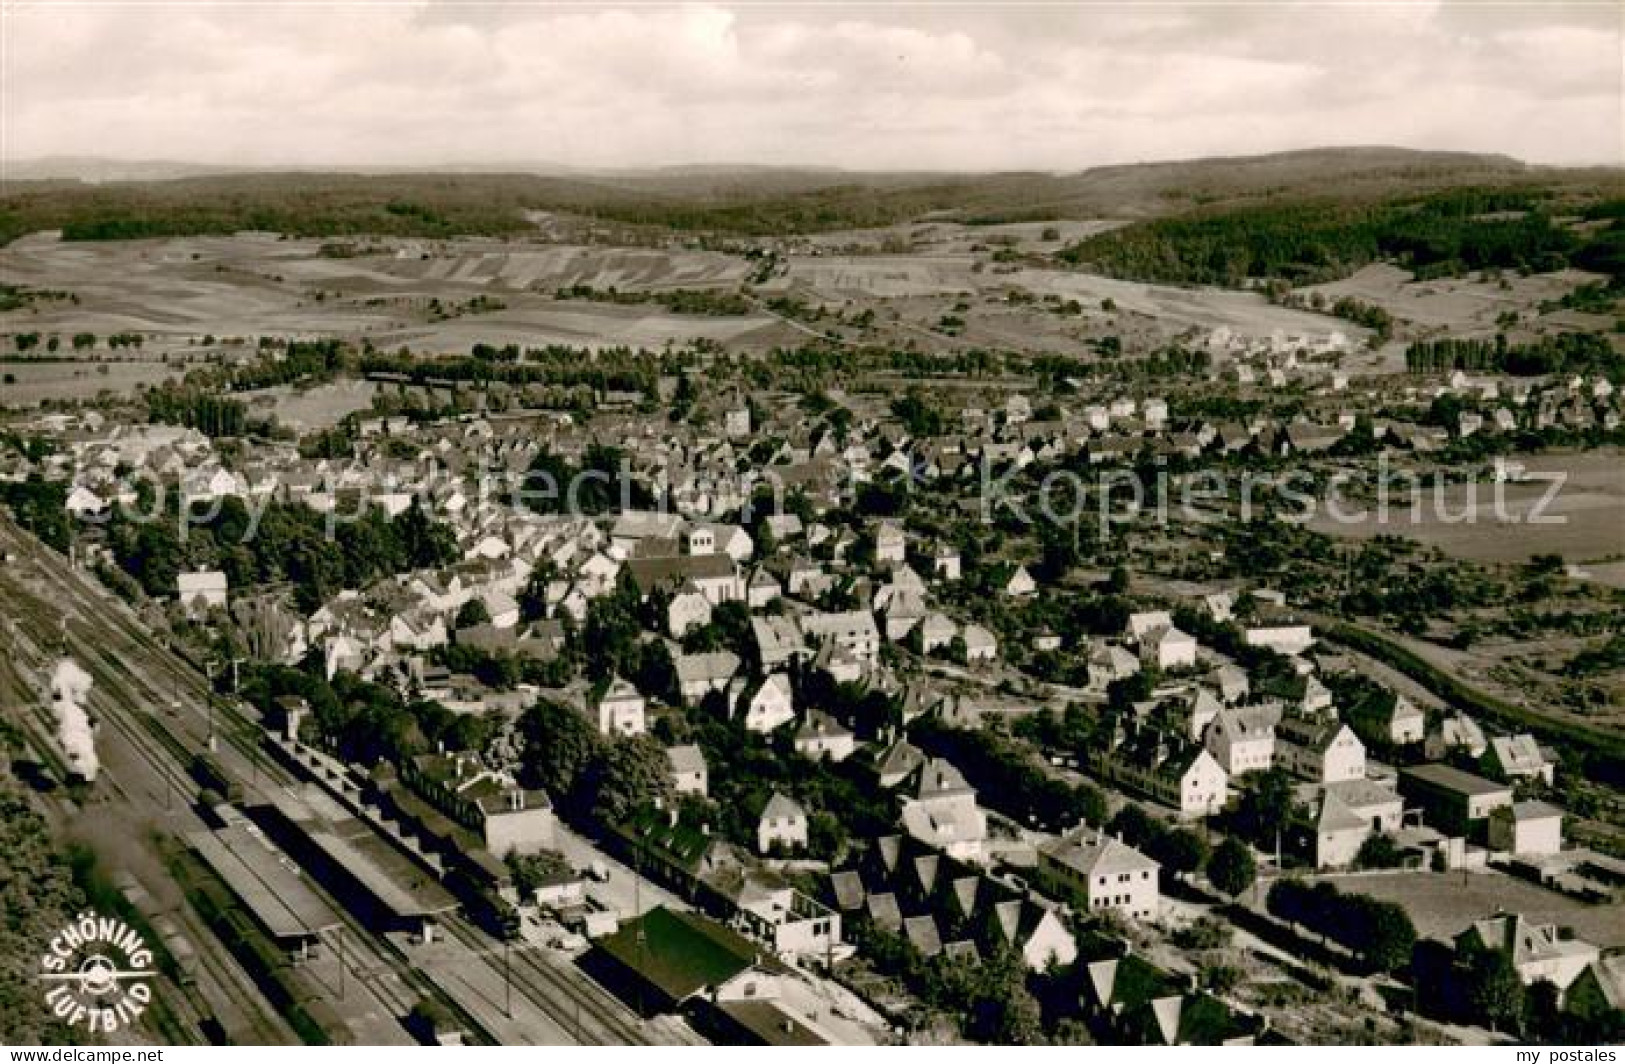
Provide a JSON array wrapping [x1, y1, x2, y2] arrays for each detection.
[[3, 183, 1625, 1045]]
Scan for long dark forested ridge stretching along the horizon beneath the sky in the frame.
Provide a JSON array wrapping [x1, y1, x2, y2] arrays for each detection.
[[0, 148, 1599, 242]]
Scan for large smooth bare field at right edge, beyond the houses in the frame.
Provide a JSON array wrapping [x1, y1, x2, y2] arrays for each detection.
[[1310, 450, 1625, 562]]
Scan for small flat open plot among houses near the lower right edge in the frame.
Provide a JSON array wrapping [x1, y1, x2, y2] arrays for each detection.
[[1313, 872, 1625, 949]]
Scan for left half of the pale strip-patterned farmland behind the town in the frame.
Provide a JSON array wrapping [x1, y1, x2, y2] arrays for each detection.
[[0, 232, 785, 351]]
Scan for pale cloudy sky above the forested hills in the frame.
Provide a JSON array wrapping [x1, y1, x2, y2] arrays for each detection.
[[0, 0, 1625, 171]]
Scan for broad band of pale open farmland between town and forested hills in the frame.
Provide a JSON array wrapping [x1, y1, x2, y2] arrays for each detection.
[[0, 221, 1365, 357]]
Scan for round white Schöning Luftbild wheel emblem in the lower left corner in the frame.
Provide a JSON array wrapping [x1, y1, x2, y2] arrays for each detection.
[[39, 913, 156, 1033]]
